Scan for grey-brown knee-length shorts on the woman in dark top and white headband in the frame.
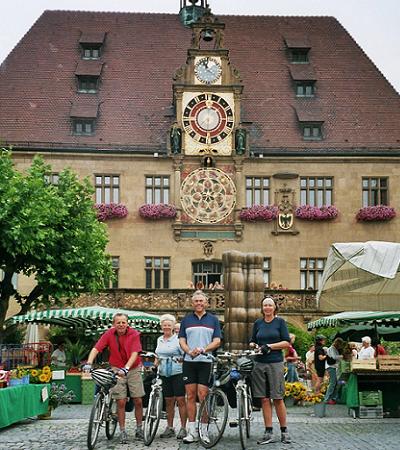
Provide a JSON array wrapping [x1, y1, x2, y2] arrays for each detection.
[[252, 362, 285, 400]]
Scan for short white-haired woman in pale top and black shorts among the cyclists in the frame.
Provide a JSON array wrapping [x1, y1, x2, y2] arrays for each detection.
[[156, 314, 187, 439]]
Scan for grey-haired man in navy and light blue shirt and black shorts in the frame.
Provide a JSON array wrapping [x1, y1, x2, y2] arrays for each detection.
[[179, 290, 221, 444]]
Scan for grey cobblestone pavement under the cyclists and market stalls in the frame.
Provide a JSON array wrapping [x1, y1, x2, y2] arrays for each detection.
[[0, 405, 400, 450]]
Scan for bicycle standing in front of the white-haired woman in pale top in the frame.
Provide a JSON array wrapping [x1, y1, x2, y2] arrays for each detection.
[[142, 352, 182, 446]]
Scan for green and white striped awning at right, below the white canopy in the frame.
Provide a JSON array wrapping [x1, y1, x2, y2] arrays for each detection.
[[307, 311, 400, 330]]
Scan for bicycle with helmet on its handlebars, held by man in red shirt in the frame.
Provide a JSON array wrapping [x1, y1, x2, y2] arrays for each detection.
[[87, 369, 118, 450]]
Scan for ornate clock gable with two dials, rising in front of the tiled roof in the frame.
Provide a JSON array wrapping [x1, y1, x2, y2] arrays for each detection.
[[173, 8, 243, 156]]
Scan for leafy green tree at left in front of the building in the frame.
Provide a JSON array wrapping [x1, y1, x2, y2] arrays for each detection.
[[0, 149, 112, 336]]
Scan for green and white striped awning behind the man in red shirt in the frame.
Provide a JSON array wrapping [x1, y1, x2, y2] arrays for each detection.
[[11, 306, 160, 333]]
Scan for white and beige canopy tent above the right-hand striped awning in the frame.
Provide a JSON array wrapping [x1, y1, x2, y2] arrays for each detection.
[[317, 241, 400, 311]]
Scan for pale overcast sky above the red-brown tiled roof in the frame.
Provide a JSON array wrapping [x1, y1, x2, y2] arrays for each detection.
[[0, 0, 400, 92]]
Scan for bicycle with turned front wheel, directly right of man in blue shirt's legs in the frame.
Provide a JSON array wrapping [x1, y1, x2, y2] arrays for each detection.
[[198, 355, 230, 448]]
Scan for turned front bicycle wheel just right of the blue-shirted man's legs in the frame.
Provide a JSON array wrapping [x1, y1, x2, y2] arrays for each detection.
[[199, 389, 228, 448]]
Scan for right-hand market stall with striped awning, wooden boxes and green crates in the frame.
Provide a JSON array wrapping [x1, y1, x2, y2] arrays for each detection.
[[308, 311, 400, 417]]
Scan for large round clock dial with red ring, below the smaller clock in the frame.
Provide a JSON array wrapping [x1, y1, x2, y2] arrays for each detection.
[[183, 94, 234, 145]]
